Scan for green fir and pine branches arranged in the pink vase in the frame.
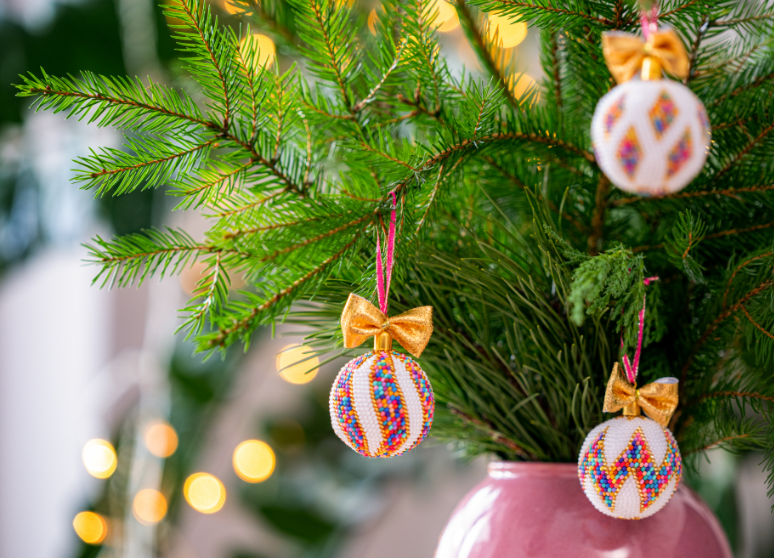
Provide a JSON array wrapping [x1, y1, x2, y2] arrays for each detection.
[[19, 0, 774, 500]]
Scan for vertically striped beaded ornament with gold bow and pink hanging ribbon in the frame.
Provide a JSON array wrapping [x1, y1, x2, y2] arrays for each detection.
[[330, 194, 435, 457]]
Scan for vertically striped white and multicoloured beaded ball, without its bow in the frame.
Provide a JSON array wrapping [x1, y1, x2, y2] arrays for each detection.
[[330, 351, 435, 457]]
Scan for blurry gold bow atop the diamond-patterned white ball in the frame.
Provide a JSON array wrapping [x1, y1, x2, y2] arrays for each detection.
[[602, 29, 690, 83]]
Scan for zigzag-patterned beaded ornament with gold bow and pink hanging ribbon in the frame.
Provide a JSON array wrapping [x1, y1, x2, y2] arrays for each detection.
[[578, 278, 682, 519]]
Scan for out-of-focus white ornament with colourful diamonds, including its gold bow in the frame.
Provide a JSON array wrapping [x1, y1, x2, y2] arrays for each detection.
[[591, 13, 711, 196]]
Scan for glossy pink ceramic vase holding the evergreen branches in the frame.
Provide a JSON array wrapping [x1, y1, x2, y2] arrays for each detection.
[[435, 462, 733, 558]]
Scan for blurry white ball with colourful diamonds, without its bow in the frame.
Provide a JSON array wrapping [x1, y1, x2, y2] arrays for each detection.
[[591, 78, 711, 196]]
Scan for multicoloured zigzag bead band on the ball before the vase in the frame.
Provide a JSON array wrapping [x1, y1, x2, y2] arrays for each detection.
[[578, 428, 682, 513]]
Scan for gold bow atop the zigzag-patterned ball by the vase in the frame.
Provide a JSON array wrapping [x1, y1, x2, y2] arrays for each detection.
[[602, 362, 677, 426]]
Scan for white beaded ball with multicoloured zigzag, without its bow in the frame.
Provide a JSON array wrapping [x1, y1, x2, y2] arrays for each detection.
[[578, 416, 683, 519]]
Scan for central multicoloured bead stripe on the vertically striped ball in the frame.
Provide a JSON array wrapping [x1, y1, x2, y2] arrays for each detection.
[[370, 351, 408, 457]]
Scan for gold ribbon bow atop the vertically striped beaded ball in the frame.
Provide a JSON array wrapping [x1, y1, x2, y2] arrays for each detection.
[[341, 293, 433, 357]]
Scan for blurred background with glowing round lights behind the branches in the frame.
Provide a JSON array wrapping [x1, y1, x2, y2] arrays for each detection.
[[0, 0, 774, 558]]
